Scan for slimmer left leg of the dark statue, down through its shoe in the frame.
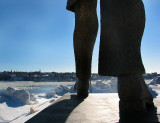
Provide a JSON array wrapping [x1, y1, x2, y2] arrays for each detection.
[[67, 0, 98, 97]]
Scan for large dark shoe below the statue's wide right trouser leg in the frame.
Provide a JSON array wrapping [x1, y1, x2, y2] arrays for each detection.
[[118, 75, 154, 113]]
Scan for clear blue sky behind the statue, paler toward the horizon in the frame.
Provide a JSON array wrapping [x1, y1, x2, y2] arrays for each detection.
[[0, 0, 160, 73]]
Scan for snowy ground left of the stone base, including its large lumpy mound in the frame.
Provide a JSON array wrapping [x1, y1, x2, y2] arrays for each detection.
[[0, 87, 60, 123]]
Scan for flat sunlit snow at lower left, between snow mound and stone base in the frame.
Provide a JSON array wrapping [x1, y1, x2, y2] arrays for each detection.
[[0, 94, 59, 123]]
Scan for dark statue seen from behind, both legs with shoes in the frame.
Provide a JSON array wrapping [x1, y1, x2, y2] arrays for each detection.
[[67, 0, 154, 113]]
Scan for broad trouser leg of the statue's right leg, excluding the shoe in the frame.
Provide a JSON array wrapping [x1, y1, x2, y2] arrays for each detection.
[[98, 0, 145, 76]]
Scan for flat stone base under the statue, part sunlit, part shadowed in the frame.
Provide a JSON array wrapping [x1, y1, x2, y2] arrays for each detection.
[[26, 93, 158, 123]]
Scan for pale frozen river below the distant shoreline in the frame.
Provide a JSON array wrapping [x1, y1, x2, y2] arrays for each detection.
[[0, 80, 151, 93]]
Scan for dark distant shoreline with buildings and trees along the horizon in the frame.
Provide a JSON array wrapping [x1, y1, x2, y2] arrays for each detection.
[[0, 71, 160, 82]]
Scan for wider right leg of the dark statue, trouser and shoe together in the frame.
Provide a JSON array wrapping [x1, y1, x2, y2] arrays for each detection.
[[99, 0, 154, 113]]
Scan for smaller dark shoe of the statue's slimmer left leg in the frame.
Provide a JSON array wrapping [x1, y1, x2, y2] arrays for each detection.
[[74, 80, 89, 98]]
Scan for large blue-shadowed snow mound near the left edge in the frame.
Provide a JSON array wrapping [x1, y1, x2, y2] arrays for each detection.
[[1, 87, 36, 104]]
